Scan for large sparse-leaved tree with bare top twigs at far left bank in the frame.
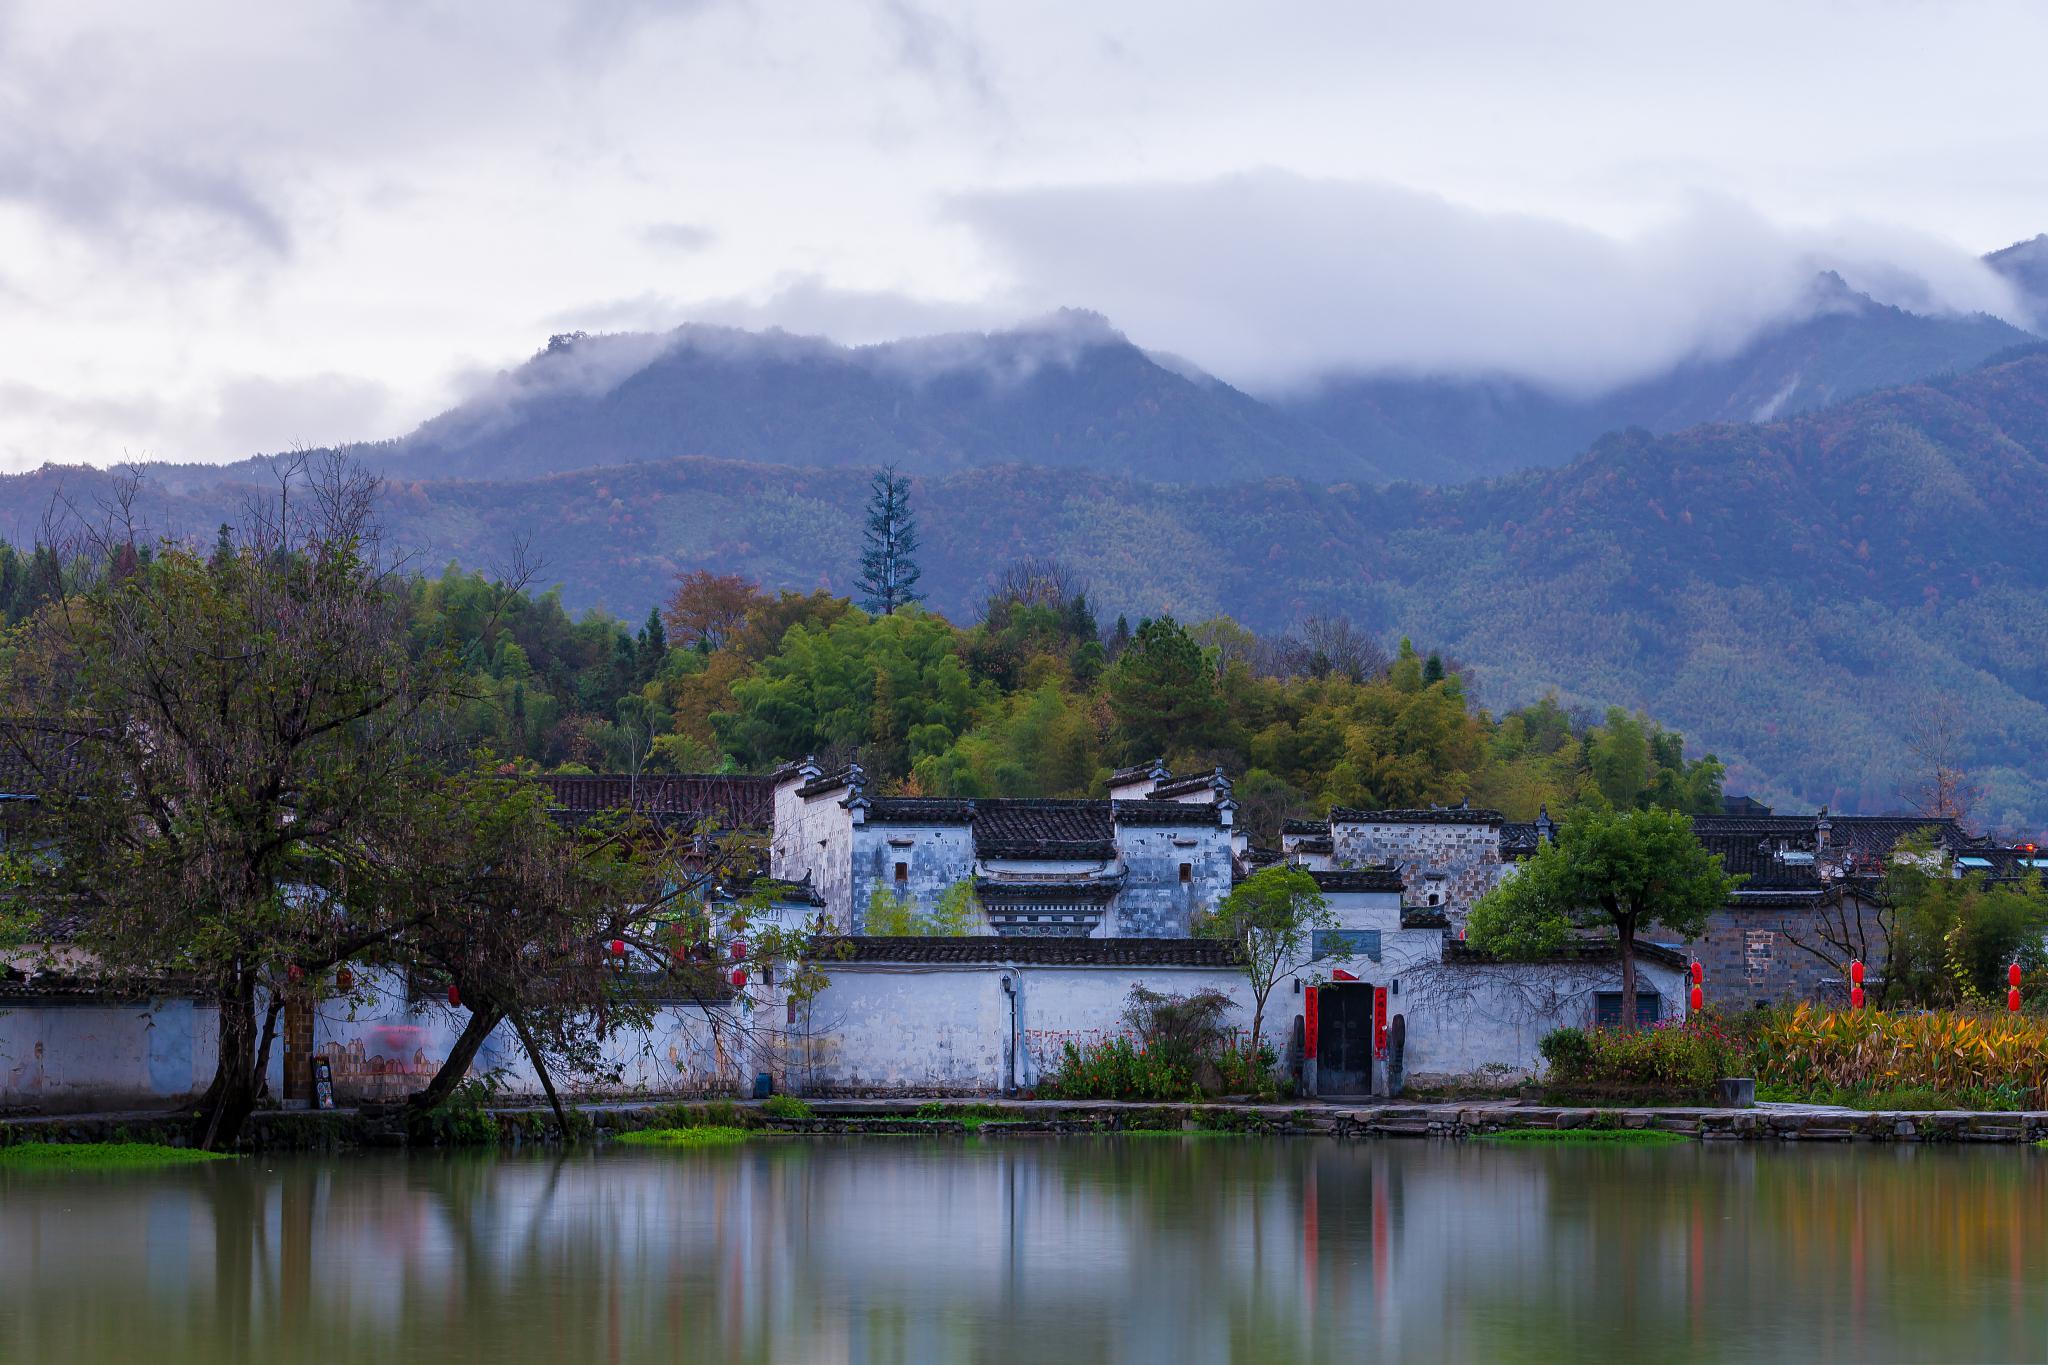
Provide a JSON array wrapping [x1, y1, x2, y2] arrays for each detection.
[[0, 463, 453, 1148]]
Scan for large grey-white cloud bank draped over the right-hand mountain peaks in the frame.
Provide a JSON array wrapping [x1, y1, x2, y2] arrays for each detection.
[[952, 170, 2021, 391]]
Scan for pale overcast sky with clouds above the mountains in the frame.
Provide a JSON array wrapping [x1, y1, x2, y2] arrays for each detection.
[[0, 0, 2048, 471]]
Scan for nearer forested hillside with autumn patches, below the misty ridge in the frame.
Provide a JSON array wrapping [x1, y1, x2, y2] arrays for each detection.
[[12, 354, 2048, 829]]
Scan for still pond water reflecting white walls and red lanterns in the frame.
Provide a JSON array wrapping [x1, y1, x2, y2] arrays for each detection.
[[0, 1138, 2048, 1365]]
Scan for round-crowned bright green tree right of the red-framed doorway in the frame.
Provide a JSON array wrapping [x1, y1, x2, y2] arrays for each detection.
[[1466, 808, 1737, 1027]]
